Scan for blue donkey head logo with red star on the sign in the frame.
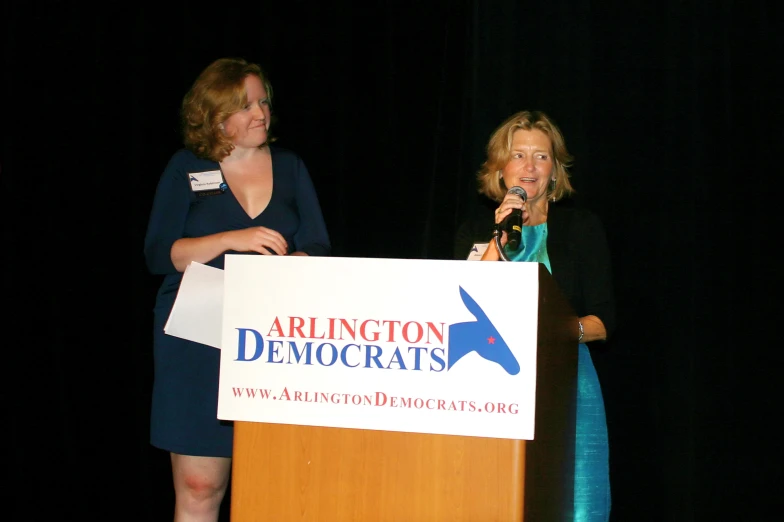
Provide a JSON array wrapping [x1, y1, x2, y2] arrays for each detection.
[[447, 286, 520, 375]]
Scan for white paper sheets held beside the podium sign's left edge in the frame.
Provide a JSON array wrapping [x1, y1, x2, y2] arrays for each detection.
[[163, 262, 223, 349]]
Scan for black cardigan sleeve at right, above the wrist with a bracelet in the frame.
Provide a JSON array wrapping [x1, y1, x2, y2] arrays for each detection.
[[572, 212, 616, 339]]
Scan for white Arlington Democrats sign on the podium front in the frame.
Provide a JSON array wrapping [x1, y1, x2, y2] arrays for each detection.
[[218, 255, 539, 440]]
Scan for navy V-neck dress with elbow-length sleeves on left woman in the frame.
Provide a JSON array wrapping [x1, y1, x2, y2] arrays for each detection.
[[144, 146, 330, 457]]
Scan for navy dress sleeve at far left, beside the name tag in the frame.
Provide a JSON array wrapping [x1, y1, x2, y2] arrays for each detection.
[[144, 151, 191, 275]]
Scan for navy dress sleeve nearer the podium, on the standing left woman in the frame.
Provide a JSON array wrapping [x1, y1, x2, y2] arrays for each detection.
[[294, 158, 332, 256]]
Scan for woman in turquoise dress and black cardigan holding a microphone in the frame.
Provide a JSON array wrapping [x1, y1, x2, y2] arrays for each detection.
[[468, 111, 615, 522]]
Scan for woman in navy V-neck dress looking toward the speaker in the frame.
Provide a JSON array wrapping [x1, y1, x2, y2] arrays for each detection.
[[144, 58, 330, 521]]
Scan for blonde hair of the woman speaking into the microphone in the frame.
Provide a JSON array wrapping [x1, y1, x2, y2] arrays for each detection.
[[477, 111, 574, 201]]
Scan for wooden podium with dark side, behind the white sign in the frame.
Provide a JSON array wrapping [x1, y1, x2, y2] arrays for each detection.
[[231, 265, 578, 522]]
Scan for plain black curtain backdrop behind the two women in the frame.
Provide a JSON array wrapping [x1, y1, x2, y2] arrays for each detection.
[[0, 0, 784, 521]]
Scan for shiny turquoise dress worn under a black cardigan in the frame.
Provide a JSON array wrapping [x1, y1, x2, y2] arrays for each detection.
[[507, 222, 610, 522]]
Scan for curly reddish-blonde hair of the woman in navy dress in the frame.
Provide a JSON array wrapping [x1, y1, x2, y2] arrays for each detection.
[[180, 58, 275, 161]]
